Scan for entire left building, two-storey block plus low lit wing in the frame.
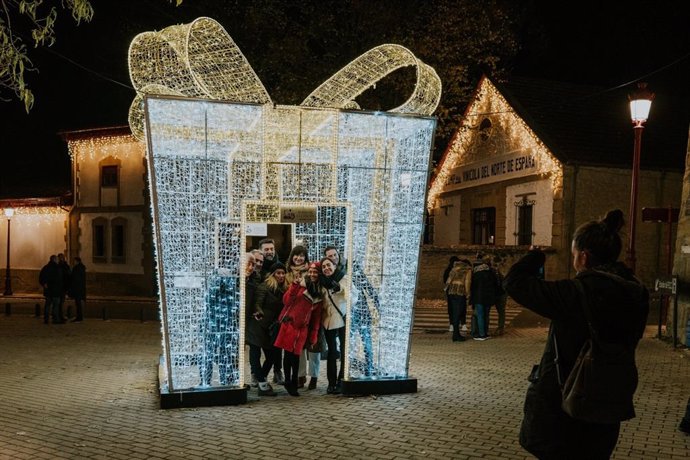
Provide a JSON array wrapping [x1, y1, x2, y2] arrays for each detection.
[[0, 127, 156, 297]]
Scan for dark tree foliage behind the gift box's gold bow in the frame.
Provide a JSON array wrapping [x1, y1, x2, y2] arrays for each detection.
[[210, 0, 525, 154]]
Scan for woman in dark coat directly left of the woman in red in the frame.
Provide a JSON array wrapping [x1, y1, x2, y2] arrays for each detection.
[[246, 262, 287, 396]]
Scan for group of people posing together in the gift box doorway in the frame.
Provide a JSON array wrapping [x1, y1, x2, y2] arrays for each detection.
[[245, 238, 355, 396]]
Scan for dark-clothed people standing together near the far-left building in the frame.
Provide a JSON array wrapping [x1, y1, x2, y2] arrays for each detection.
[[38, 253, 86, 324]]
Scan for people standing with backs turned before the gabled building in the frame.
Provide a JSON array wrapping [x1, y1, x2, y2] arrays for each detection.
[[443, 254, 507, 342]]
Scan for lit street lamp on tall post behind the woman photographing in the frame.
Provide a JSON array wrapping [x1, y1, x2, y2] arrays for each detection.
[[627, 83, 654, 272]]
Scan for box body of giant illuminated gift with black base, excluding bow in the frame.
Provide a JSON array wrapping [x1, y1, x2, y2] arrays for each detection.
[[130, 18, 440, 407]]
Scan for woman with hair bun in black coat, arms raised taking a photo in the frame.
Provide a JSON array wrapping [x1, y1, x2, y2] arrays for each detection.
[[504, 210, 649, 459]]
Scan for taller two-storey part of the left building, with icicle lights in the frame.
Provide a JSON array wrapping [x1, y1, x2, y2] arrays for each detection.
[[63, 127, 155, 296]]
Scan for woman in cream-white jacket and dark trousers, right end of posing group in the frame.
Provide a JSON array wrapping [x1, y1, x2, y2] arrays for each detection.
[[321, 258, 357, 394]]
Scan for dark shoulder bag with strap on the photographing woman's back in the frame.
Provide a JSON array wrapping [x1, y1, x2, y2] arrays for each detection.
[[554, 279, 637, 423]]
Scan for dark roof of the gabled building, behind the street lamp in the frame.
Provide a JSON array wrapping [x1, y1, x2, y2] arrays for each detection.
[[492, 77, 688, 171]]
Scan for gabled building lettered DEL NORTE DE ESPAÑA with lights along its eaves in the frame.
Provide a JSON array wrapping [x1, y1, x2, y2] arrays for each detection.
[[418, 77, 687, 297]]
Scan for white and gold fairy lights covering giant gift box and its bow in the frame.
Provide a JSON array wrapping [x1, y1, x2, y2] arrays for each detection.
[[129, 18, 441, 390]]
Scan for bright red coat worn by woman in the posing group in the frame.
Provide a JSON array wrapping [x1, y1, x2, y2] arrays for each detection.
[[275, 282, 323, 355]]
